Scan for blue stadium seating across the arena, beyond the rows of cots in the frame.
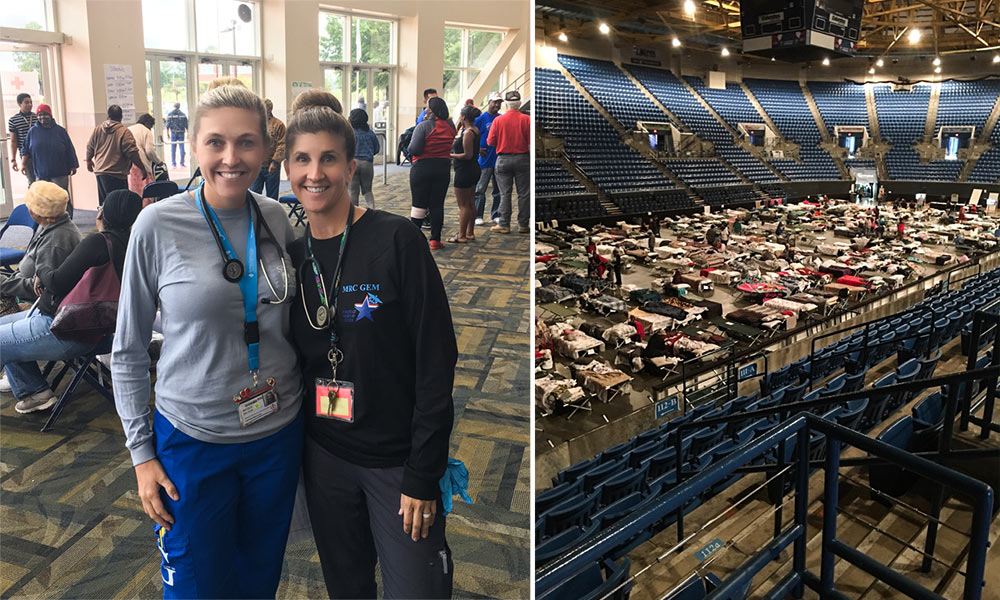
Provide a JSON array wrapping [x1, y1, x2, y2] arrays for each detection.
[[535, 55, 1000, 218]]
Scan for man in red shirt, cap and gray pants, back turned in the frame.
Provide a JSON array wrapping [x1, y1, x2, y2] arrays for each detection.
[[487, 90, 531, 235]]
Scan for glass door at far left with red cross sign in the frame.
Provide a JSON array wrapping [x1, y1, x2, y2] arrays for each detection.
[[0, 44, 51, 217]]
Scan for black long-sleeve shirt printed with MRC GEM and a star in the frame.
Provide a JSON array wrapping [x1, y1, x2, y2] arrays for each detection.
[[289, 210, 458, 500]]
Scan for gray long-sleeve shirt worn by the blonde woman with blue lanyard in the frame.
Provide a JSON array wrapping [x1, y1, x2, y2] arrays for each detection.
[[111, 192, 303, 465]]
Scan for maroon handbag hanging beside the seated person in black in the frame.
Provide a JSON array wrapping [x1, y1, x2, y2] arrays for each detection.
[[49, 234, 122, 344]]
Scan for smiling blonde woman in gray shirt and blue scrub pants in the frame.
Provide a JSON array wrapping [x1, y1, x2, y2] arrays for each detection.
[[112, 85, 303, 598]]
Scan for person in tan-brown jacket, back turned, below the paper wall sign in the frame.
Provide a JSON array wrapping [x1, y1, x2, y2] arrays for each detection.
[[87, 104, 148, 205]]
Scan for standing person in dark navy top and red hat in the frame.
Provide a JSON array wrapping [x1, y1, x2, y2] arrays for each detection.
[[24, 104, 80, 219]]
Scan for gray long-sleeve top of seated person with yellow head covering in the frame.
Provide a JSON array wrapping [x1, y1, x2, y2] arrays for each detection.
[[0, 213, 83, 300]]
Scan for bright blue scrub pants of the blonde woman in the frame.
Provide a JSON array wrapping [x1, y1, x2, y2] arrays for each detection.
[[153, 408, 304, 598]]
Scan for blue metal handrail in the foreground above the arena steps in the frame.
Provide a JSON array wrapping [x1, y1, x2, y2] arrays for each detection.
[[535, 412, 993, 600]]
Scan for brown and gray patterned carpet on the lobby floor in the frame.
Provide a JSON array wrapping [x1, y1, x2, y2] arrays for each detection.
[[0, 167, 531, 599]]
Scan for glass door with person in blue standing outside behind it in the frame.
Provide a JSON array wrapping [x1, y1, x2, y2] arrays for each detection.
[[146, 55, 194, 184]]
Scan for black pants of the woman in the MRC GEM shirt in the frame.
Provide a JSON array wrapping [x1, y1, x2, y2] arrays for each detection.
[[302, 434, 454, 598]]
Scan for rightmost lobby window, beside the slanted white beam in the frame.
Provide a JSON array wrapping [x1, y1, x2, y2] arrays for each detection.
[[441, 27, 504, 110]]
